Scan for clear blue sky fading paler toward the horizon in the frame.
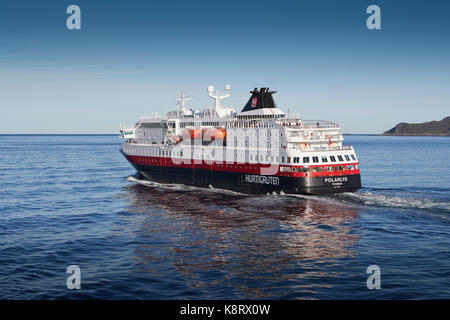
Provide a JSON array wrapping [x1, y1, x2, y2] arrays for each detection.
[[0, 0, 450, 133]]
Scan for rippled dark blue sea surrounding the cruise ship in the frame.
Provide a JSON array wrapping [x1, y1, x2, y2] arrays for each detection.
[[0, 135, 450, 299]]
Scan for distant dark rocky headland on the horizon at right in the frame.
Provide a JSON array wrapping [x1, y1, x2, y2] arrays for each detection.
[[383, 117, 450, 136]]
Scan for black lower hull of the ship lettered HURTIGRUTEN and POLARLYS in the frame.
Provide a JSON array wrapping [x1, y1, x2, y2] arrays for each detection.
[[124, 153, 361, 194]]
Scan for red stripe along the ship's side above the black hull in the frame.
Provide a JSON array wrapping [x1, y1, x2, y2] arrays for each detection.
[[126, 155, 359, 177]]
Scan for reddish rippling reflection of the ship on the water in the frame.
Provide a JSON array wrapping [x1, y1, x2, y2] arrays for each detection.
[[116, 185, 360, 298]]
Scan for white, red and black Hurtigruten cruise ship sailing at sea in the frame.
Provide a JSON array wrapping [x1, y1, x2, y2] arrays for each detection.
[[120, 85, 361, 194]]
